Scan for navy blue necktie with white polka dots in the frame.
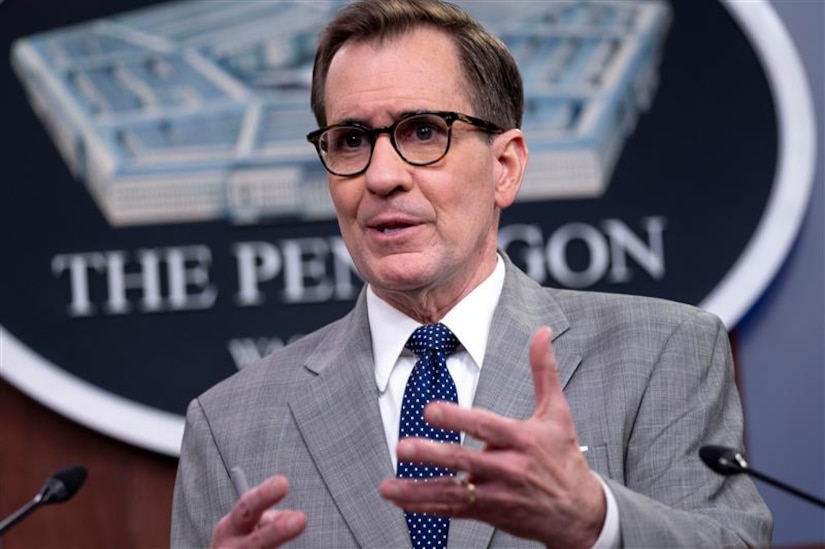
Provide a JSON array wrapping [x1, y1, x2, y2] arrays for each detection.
[[398, 324, 461, 549]]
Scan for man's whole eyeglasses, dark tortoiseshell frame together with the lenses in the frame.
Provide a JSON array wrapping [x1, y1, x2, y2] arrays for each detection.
[[307, 111, 504, 177]]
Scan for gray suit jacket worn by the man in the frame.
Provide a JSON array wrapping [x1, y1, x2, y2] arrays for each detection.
[[172, 261, 771, 548]]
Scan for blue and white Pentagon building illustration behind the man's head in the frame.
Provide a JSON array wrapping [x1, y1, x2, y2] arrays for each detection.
[[12, 0, 671, 226]]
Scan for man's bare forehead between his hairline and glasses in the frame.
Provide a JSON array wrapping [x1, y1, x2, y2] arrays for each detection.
[[324, 27, 474, 124]]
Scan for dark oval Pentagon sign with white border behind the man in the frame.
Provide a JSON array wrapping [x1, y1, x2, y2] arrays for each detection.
[[0, 0, 815, 454]]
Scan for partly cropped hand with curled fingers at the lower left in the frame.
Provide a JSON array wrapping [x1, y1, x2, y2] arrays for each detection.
[[212, 476, 306, 547]]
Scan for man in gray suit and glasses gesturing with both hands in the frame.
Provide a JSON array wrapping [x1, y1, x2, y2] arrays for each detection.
[[172, 0, 771, 547]]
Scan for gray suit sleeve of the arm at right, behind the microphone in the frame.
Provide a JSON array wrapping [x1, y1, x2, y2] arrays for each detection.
[[607, 312, 772, 547]]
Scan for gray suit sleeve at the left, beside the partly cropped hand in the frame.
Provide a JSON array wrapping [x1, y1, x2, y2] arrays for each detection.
[[171, 399, 234, 549]]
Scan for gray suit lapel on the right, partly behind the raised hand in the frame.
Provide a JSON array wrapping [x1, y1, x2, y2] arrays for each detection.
[[449, 259, 581, 547]]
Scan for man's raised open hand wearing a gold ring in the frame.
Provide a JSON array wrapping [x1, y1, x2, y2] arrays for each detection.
[[380, 327, 606, 547]]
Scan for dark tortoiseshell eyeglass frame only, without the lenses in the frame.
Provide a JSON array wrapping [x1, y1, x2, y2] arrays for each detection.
[[307, 111, 506, 177]]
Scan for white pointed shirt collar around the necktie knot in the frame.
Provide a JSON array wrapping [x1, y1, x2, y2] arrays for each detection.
[[367, 255, 505, 393]]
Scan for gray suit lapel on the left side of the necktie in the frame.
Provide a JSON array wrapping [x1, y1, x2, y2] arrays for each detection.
[[289, 293, 409, 547]]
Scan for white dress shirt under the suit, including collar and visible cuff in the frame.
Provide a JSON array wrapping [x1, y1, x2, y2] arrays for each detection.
[[367, 256, 619, 548]]
